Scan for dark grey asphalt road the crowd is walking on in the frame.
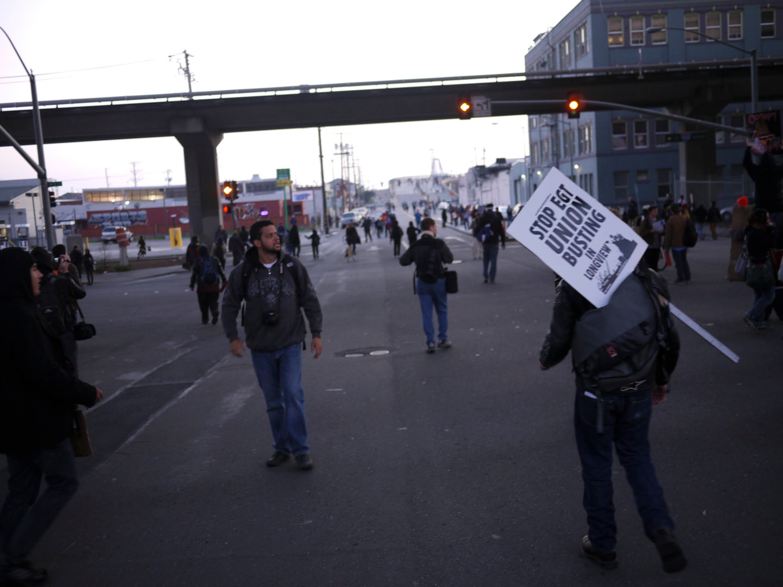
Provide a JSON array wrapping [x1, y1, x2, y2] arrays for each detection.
[[0, 223, 783, 587]]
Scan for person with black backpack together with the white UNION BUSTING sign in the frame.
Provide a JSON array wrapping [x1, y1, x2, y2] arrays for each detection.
[[509, 169, 687, 573]]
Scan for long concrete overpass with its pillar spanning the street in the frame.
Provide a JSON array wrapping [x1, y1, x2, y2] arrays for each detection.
[[0, 59, 783, 237]]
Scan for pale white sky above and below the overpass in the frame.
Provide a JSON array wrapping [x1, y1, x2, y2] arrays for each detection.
[[0, 0, 578, 193]]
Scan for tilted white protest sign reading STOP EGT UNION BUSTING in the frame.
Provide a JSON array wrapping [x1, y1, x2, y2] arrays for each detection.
[[508, 168, 647, 308]]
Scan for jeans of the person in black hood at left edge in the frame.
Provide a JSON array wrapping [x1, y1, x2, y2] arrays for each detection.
[[0, 439, 79, 564]]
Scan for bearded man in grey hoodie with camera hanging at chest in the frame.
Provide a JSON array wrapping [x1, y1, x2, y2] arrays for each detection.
[[222, 220, 322, 471]]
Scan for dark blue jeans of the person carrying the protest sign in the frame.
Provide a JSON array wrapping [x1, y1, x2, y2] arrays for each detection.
[[574, 390, 674, 551]]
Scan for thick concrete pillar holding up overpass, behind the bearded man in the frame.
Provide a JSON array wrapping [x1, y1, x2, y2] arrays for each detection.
[[172, 118, 223, 243]]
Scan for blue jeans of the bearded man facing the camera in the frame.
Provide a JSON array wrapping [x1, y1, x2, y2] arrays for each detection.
[[251, 344, 310, 455]]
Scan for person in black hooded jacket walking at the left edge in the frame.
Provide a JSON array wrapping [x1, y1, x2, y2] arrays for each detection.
[[0, 248, 103, 585]]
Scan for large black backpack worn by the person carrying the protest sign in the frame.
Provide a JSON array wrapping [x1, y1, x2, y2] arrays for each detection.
[[571, 272, 679, 394]]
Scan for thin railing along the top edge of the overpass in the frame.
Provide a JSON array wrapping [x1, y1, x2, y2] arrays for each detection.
[[0, 58, 783, 111]]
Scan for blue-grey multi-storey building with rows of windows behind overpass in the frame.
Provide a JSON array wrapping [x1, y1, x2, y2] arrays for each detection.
[[525, 0, 783, 206]]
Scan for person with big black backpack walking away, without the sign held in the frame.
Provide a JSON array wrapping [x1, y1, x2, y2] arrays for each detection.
[[540, 261, 687, 573]]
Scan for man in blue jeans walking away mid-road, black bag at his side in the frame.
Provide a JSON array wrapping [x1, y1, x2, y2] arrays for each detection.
[[400, 218, 454, 354]]
